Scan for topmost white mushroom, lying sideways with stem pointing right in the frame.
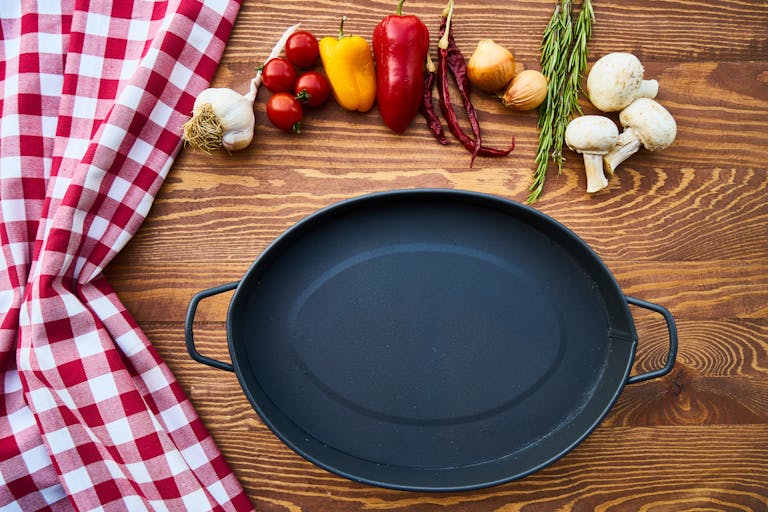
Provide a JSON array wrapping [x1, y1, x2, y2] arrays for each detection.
[[587, 52, 659, 112]]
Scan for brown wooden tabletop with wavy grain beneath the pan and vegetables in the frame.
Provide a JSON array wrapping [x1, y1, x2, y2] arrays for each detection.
[[103, 0, 768, 512]]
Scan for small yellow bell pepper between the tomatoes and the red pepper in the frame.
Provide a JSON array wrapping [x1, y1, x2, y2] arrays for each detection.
[[320, 16, 376, 112]]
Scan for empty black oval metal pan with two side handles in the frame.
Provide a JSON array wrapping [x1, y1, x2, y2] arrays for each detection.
[[186, 190, 677, 491]]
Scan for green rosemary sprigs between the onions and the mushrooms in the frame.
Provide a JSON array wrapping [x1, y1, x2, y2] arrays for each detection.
[[528, 0, 595, 203]]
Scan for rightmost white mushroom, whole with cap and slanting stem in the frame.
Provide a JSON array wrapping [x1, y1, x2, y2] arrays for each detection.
[[603, 98, 677, 174]]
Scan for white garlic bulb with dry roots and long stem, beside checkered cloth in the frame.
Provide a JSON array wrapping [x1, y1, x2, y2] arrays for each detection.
[[183, 23, 301, 154]]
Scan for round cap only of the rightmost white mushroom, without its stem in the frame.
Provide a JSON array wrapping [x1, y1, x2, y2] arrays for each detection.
[[619, 98, 677, 151]]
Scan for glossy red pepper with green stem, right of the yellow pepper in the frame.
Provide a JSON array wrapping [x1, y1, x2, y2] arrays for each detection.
[[373, 0, 429, 133]]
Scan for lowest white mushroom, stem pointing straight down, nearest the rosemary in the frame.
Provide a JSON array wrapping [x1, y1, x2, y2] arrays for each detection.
[[565, 116, 619, 194]]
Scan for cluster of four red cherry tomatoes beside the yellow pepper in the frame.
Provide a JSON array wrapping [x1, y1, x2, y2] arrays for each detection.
[[261, 31, 331, 133]]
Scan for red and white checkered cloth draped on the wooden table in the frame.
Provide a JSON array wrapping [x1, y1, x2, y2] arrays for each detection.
[[0, 0, 253, 512]]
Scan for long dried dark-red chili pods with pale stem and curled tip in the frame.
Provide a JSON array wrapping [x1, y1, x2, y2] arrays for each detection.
[[437, 0, 515, 167]]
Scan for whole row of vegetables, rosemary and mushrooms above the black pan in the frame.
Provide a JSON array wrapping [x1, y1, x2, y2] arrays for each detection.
[[183, 0, 677, 203]]
